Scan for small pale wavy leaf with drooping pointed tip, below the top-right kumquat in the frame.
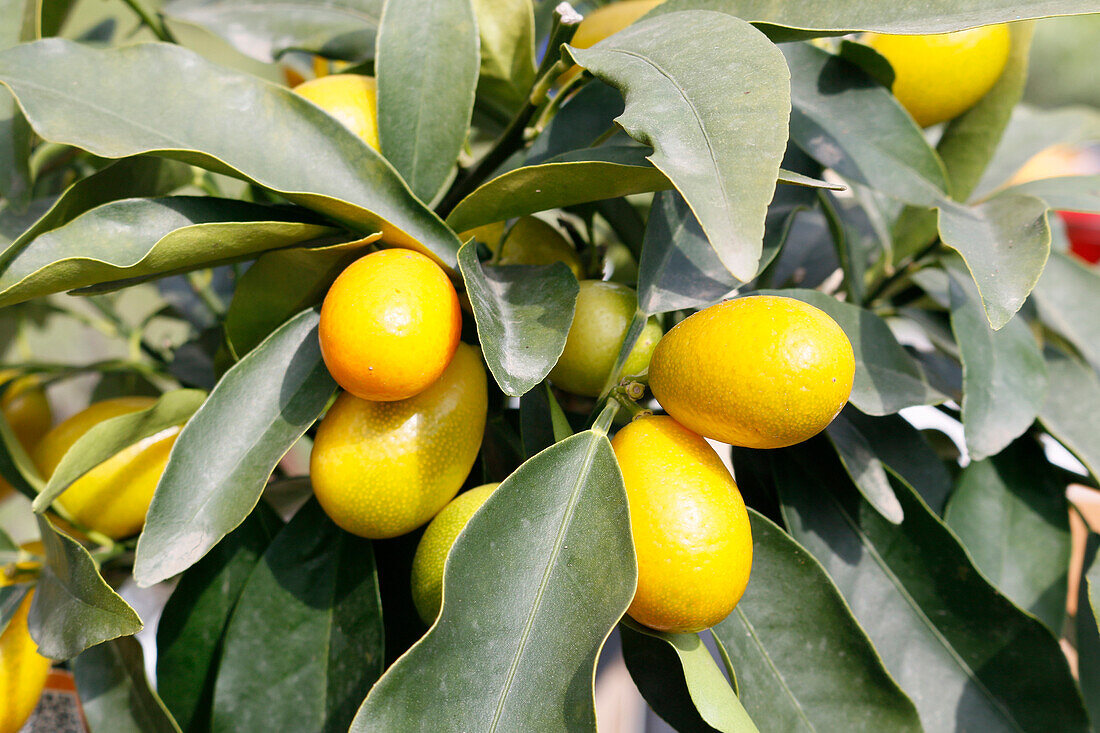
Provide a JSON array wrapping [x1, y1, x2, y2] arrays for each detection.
[[939, 194, 1051, 329]]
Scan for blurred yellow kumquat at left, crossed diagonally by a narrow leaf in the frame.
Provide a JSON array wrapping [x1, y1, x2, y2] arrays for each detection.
[[31, 397, 180, 539]]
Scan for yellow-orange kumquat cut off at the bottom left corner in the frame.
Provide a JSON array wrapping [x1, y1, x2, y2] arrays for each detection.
[[0, 569, 53, 733]]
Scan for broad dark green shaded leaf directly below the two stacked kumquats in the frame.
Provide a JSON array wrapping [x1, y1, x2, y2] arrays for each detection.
[[212, 500, 383, 733]]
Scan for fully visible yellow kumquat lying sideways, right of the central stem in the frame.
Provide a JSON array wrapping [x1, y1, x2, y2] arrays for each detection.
[[649, 295, 856, 448]]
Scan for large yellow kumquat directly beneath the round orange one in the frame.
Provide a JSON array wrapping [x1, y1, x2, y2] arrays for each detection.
[[309, 343, 487, 539]]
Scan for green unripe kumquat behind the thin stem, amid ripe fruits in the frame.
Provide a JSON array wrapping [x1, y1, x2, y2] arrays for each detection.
[[550, 280, 661, 397]]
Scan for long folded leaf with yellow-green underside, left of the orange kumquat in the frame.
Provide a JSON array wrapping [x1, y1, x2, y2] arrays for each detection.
[[0, 196, 340, 305]]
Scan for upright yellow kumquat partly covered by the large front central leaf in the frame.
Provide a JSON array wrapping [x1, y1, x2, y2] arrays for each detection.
[[612, 415, 752, 633]]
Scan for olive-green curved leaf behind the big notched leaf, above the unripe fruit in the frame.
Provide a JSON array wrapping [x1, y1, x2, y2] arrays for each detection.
[[447, 144, 671, 231]]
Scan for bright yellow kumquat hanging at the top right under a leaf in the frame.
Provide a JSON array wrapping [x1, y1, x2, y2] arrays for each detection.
[[865, 24, 1012, 128]]
